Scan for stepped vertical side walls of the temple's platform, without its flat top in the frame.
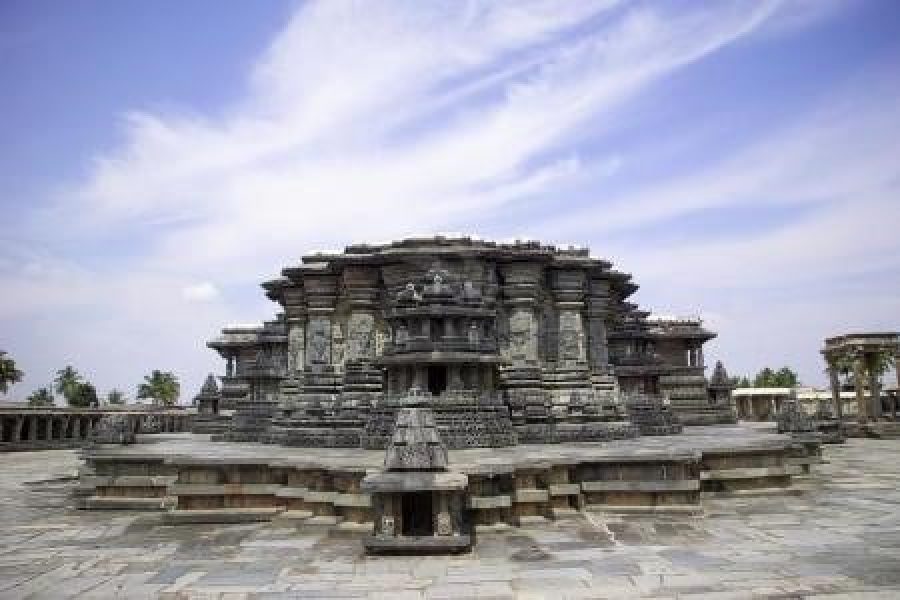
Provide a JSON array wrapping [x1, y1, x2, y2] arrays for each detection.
[[78, 438, 821, 528]]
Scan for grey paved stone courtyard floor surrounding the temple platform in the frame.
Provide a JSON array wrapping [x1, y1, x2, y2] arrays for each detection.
[[0, 440, 900, 600]]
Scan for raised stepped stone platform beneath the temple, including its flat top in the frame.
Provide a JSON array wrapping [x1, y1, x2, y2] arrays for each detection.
[[78, 426, 820, 527]]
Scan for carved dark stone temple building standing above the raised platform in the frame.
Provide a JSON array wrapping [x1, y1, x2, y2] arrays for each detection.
[[207, 237, 735, 449]]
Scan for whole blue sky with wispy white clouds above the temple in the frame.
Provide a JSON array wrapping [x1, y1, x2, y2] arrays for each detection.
[[0, 0, 900, 399]]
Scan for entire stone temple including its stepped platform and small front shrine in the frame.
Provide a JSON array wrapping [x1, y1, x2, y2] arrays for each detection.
[[75, 237, 821, 562]]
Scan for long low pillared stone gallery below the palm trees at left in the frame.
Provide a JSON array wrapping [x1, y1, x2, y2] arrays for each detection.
[[0, 407, 190, 452]]
